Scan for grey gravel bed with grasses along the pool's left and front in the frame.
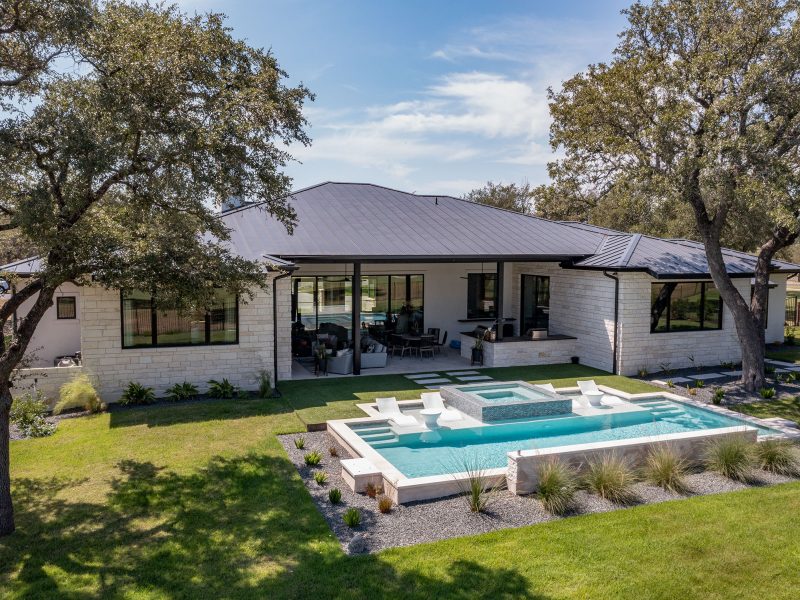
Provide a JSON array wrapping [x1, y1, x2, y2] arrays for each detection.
[[278, 431, 794, 554]]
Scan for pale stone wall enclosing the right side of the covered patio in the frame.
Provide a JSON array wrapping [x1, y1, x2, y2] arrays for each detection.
[[510, 263, 616, 371]]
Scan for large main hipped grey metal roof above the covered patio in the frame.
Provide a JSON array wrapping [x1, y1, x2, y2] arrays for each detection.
[[221, 182, 603, 261]]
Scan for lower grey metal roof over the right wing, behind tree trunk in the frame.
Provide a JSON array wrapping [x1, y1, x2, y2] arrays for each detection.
[[562, 221, 800, 278]]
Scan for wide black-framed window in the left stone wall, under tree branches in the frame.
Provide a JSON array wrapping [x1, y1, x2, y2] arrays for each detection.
[[120, 290, 239, 348]]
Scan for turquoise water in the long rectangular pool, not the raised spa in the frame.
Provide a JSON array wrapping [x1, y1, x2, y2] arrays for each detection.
[[353, 398, 777, 477]]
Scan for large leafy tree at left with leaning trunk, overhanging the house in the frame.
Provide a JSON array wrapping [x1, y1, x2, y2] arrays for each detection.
[[0, 0, 312, 534]]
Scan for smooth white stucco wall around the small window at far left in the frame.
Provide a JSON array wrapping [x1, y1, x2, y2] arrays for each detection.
[[2, 283, 83, 367]]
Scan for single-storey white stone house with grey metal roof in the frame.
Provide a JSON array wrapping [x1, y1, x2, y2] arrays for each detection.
[[0, 182, 800, 401]]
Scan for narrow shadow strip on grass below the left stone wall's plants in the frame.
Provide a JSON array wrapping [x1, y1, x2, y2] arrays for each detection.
[[104, 398, 293, 427]]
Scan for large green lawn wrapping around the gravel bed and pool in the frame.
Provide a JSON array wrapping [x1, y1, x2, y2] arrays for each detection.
[[0, 367, 800, 600]]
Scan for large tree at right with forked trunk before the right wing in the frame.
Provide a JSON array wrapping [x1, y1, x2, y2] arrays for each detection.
[[539, 0, 800, 390]]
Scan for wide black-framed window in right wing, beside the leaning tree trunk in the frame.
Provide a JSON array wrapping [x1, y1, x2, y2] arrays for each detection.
[[650, 281, 722, 333]]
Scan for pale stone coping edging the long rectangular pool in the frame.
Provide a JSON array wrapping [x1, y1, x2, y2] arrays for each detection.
[[327, 385, 800, 504]]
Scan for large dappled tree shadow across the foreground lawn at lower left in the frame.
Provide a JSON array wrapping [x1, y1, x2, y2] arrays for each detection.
[[0, 454, 552, 598]]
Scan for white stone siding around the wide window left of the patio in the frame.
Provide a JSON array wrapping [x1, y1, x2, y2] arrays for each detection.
[[81, 276, 292, 402]]
